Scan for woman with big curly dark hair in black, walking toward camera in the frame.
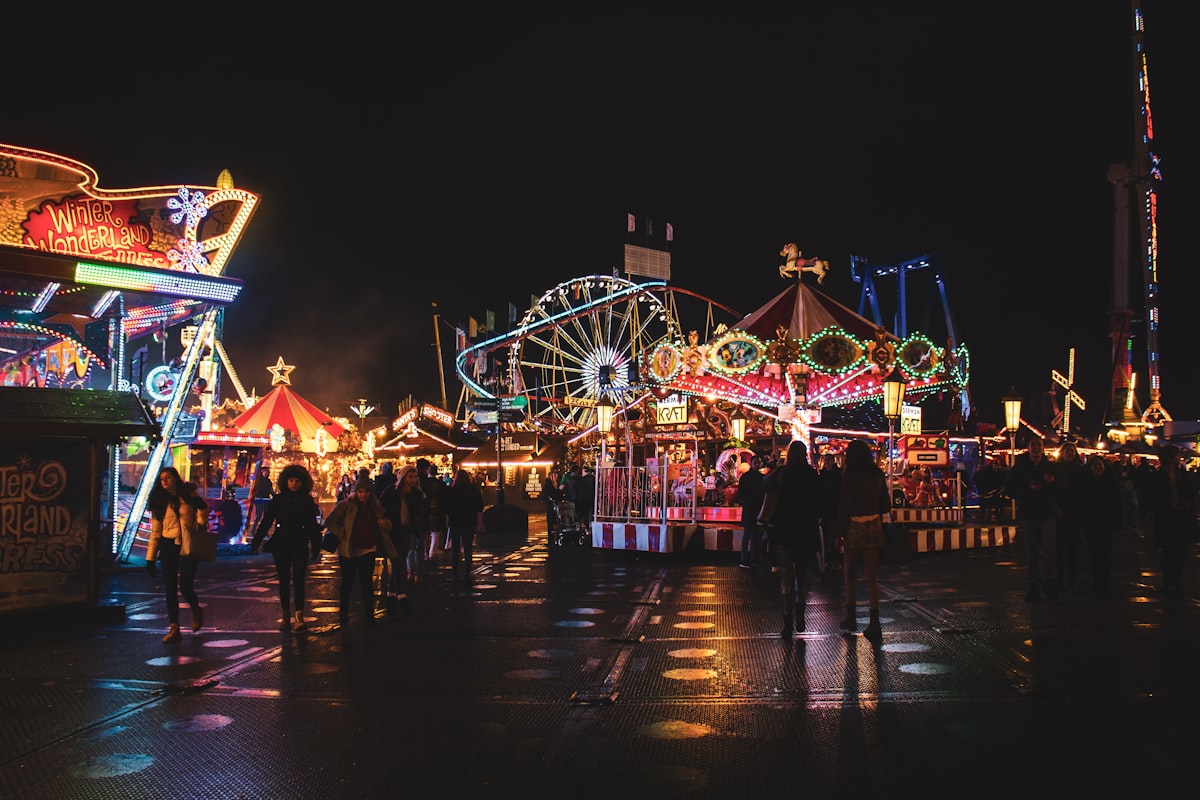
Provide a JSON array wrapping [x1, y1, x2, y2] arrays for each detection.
[[250, 464, 323, 633]]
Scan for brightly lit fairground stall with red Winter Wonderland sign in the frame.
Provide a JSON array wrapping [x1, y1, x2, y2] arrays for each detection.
[[0, 144, 258, 568]]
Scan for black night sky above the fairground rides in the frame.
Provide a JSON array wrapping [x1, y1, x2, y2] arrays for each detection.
[[0, 0, 1200, 431]]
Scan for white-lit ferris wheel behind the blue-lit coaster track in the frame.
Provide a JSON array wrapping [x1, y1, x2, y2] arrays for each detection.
[[508, 275, 682, 431]]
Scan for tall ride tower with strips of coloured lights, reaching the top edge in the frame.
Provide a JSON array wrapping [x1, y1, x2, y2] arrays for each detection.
[[1108, 0, 1171, 438]]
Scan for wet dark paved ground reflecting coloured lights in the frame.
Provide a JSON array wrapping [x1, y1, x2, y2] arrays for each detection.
[[0, 520, 1200, 800]]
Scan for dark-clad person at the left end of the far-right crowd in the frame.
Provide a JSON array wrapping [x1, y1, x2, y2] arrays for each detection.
[[1004, 437, 1058, 603]]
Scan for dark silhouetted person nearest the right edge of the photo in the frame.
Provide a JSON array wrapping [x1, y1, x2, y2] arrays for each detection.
[[1146, 445, 1196, 597]]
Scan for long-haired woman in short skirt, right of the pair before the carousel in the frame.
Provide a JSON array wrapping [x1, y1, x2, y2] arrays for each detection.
[[838, 439, 892, 639]]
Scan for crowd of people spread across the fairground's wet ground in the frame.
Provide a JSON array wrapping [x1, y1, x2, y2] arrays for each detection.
[[146, 437, 1200, 643]]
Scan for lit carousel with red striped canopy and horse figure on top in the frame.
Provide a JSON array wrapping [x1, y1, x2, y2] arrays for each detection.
[[593, 245, 970, 552]]
